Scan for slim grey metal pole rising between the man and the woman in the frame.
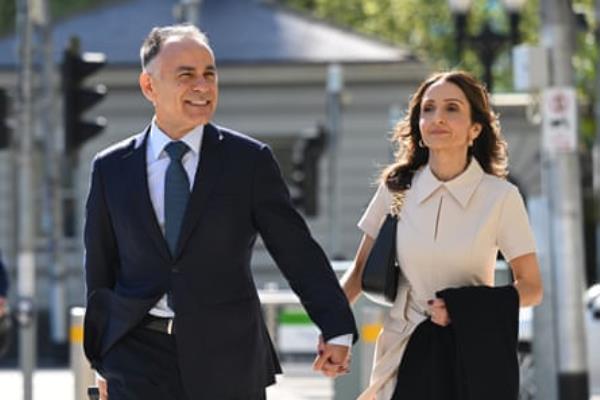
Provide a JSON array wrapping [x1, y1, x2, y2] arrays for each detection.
[[327, 64, 344, 259]]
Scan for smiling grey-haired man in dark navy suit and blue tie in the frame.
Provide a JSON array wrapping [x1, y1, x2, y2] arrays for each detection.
[[84, 25, 356, 400]]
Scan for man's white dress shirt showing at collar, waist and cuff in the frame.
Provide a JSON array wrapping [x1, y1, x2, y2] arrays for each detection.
[[141, 119, 352, 346]]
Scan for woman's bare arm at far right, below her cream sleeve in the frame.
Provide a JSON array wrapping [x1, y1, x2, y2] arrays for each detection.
[[510, 253, 544, 307]]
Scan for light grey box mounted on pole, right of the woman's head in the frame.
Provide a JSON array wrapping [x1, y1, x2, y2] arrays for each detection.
[[513, 45, 548, 92]]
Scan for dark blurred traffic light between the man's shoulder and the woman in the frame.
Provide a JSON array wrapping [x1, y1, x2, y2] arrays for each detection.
[[291, 127, 327, 216]]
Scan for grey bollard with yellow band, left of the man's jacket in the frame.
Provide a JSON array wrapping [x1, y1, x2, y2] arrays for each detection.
[[69, 307, 95, 400]]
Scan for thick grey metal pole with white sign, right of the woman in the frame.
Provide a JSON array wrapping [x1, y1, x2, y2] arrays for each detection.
[[540, 0, 589, 400]]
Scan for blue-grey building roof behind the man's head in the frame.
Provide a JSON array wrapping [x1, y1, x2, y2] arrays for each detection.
[[0, 0, 412, 67]]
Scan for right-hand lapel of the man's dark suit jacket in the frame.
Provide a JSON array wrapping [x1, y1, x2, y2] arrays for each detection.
[[177, 124, 223, 255]]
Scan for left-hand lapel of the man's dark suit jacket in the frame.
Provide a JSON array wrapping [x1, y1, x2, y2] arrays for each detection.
[[123, 127, 171, 260]]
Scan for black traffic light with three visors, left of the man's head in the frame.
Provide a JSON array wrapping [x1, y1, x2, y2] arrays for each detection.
[[62, 39, 106, 154]]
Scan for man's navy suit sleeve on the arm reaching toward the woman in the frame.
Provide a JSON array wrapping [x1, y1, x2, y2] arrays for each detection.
[[253, 147, 358, 342]]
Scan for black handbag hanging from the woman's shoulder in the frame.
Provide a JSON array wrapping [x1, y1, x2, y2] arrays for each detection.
[[361, 214, 400, 306]]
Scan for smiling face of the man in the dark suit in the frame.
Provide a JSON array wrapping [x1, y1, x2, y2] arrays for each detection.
[[140, 37, 219, 138]]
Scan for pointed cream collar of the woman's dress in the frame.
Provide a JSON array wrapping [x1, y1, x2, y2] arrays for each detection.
[[415, 158, 484, 208]]
